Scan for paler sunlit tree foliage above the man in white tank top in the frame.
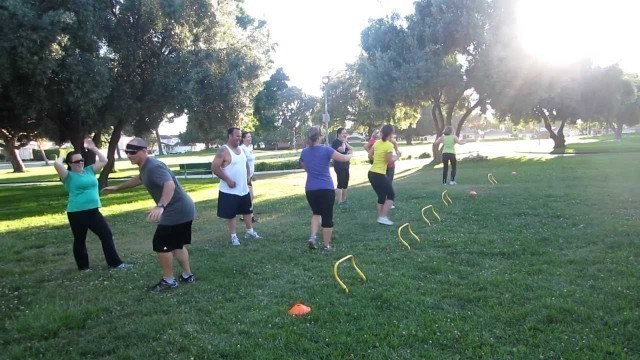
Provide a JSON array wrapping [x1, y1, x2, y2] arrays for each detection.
[[187, 1, 272, 148]]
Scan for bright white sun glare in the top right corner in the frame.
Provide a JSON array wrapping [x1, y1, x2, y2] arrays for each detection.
[[517, 0, 640, 72]]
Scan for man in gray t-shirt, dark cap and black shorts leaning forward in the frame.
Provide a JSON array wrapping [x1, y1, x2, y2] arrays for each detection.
[[103, 138, 196, 291]]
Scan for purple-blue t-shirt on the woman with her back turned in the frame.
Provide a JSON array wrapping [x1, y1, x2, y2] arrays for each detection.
[[300, 145, 335, 191]]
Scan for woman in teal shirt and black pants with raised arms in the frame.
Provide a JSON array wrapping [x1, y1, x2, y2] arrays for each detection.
[[53, 140, 133, 271]]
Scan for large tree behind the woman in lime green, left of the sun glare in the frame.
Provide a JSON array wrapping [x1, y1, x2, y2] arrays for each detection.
[[361, 0, 491, 161]]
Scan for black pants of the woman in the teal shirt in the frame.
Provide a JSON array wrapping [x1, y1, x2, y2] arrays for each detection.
[[67, 208, 122, 270]]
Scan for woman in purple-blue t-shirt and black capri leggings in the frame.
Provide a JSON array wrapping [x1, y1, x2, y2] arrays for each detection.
[[300, 126, 351, 251]]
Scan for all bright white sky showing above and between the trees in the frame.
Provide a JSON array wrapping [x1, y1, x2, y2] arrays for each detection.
[[161, 0, 640, 134]]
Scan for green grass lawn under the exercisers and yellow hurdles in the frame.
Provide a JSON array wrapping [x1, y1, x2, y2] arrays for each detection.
[[0, 143, 640, 359]]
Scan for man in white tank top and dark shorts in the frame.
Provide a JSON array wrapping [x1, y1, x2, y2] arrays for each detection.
[[211, 128, 262, 246]]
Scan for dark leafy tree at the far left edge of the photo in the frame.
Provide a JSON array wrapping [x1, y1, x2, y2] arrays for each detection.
[[0, 0, 73, 172]]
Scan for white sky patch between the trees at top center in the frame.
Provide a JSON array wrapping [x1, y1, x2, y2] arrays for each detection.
[[245, 0, 413, 95]]
